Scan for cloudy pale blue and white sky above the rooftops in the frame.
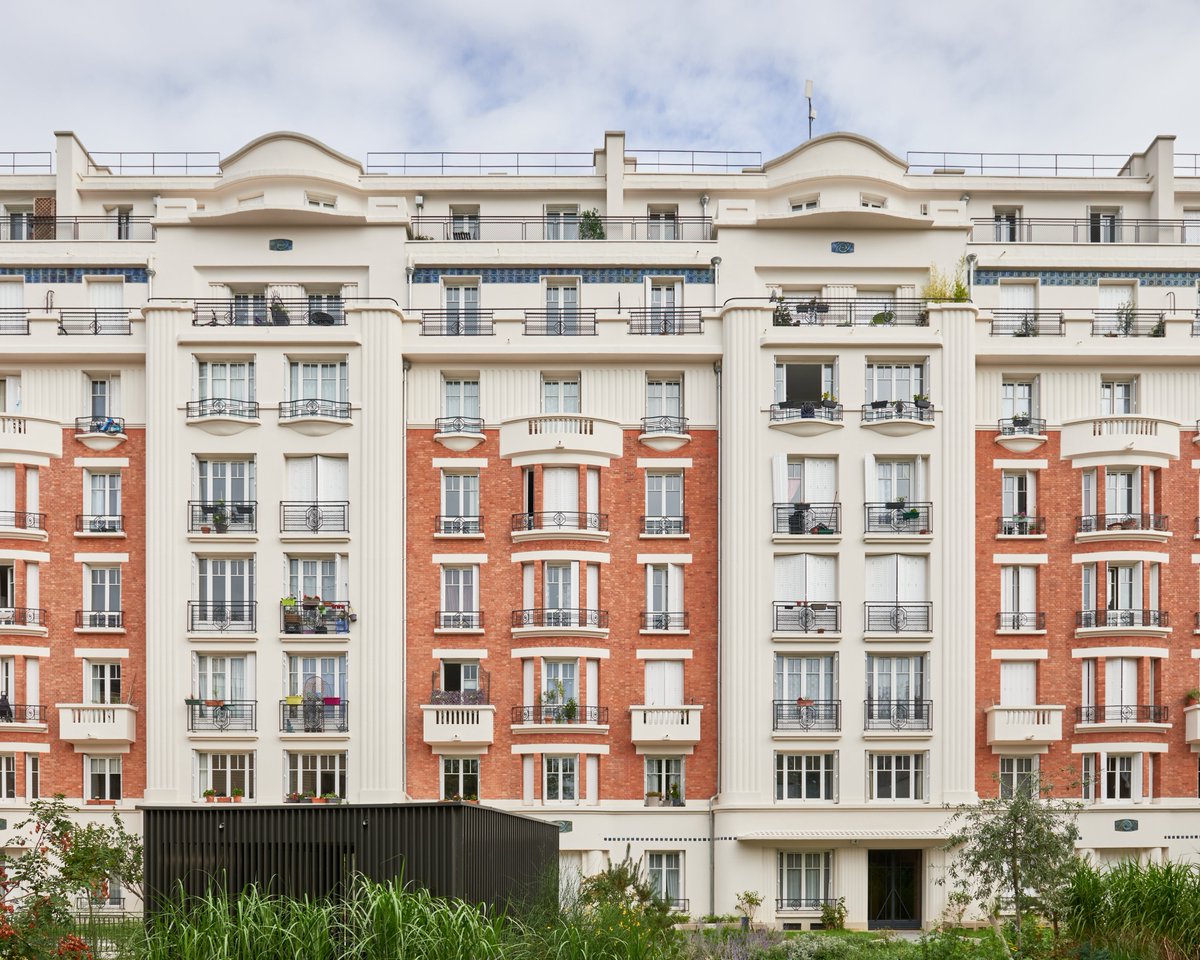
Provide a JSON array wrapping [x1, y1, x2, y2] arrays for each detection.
[[11, 0, 1200, 165]]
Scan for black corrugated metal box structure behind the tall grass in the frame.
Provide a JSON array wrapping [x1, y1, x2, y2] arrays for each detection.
[[142, 803, 558, 912]]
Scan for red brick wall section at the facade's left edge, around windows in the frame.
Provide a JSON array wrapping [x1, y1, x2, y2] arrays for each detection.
[[0, 428, 146, 799]]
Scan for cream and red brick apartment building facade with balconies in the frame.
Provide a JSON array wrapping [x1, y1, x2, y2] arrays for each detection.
[[0, 123, 1200, 926]]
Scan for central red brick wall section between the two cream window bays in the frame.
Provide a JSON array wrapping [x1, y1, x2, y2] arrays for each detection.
[[407, 431, 718, 799]]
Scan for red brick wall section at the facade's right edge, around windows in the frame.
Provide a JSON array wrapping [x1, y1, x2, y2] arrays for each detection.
[[976, 431, 1198, 797]]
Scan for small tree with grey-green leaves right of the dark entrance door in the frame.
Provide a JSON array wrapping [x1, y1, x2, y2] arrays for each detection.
[[937, 781, 1080, 955]]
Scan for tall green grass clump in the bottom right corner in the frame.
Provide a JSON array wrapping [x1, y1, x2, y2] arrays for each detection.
[[1066, 860, 1200, 960]]
